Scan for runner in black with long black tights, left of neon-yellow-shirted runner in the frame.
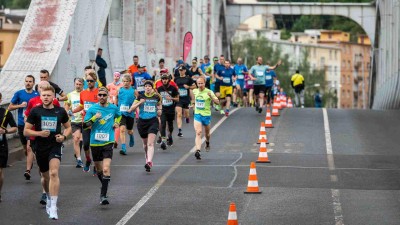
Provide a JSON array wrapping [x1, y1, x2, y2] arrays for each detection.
[[157, 74, 179, 150]]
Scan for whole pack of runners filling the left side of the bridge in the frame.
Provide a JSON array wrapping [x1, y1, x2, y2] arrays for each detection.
[[0, 55, 280, 219]]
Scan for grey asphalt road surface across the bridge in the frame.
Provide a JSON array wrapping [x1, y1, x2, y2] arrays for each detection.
[[0, 108, 400, 225]]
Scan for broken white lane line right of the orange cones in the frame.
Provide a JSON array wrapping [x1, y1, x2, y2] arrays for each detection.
[[322, 108, 344, 225]]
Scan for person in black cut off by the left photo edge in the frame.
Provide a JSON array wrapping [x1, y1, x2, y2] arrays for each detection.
[[0, 93, 18, 202]]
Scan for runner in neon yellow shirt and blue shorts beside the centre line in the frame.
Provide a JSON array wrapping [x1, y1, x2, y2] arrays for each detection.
[[192, 78, 219, 160]]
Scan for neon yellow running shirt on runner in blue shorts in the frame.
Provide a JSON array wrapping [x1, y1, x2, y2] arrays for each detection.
[[193, 88, 216, 116]]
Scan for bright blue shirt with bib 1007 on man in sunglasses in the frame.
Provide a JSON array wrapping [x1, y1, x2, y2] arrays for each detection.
[[85, 103, 121, 146]]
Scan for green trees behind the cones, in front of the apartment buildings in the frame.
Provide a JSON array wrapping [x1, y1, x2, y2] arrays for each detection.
[[232, 38, 337, 107]]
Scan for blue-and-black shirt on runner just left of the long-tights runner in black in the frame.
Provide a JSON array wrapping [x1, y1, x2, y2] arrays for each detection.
[[135, 92, 161, 120]]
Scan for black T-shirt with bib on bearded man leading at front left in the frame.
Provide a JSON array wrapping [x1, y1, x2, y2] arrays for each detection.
[[26, 105, 69, 147]]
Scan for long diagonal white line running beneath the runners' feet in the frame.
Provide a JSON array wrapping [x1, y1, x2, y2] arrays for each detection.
[[116, 108, 239, 225]]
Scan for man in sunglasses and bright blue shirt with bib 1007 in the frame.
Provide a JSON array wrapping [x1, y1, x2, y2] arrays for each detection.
[[83, 86, 121, 205]]
